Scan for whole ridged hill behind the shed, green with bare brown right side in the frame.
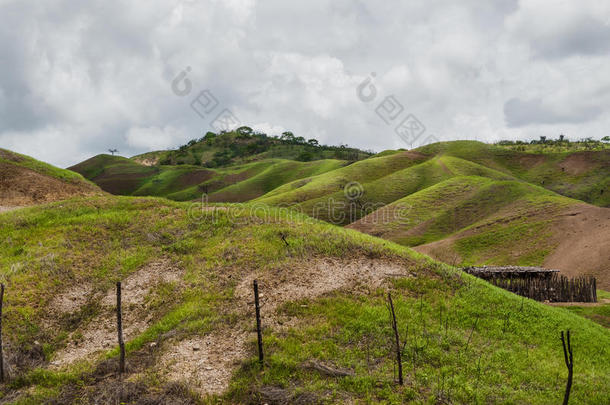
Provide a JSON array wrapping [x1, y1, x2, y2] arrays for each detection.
[[348, 176, 610, 289]]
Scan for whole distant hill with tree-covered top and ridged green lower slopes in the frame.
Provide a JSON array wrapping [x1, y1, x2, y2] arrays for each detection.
[[69, 127, 372, 202]]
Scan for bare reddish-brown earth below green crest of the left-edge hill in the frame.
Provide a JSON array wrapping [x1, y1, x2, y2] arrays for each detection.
[[0, 162, 100, 205]]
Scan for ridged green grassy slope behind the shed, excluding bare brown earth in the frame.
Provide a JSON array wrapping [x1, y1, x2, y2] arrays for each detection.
[[350, 176, 580, 265]]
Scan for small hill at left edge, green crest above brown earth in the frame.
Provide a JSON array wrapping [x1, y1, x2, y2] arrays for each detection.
[[0, 149, 101, 210]]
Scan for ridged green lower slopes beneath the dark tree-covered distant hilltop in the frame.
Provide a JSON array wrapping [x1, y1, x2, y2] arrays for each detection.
[[70, 155, 347, 202]]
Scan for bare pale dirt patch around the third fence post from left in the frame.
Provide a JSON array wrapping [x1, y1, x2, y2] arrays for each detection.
[[159, 259, 409, 395]]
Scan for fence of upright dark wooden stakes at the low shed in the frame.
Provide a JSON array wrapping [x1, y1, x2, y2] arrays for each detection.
[[489, 274, 597, 302]]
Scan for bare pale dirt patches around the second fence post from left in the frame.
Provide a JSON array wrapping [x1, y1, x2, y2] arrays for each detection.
[[50, 260, 182, 368]]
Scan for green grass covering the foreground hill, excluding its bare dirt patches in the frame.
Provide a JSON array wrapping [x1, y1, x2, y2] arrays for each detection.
[[0, 197, 610, 403]]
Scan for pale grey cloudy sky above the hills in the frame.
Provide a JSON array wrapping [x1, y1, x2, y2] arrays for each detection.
[[0, 0, 610, 167]]
